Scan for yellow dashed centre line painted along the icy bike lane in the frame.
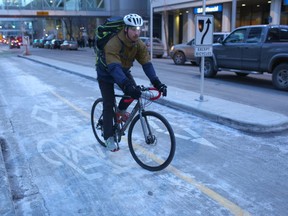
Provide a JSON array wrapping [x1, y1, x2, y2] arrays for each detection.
[[46, 90, 250, 216]]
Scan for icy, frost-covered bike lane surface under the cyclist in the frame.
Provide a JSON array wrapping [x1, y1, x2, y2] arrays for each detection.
[[0, 52, 288, 216]]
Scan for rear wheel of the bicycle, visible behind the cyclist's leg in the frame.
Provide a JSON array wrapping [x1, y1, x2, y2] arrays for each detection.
[[91, 98, 106, 147]]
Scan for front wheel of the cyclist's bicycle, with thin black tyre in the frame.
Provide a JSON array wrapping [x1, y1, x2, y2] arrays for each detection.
[[128, 111, 176, 171]]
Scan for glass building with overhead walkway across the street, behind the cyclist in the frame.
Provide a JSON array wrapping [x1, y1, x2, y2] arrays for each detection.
[[0, 0, 149, 44]]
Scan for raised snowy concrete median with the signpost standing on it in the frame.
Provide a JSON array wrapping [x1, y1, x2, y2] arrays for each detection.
[[18, 52, 288, 133]]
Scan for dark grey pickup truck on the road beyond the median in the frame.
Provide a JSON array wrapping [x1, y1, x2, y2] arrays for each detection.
[[204, 25, 288, 90]]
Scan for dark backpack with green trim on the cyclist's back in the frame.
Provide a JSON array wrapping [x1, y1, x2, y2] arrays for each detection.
[[94, 17, 125, 68]]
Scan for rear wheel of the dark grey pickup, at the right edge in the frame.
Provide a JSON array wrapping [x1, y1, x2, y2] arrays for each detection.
[[272, 63, 288, 90]]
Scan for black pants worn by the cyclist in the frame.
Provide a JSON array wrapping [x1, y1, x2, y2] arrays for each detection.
[[98, 76, 135, 140]]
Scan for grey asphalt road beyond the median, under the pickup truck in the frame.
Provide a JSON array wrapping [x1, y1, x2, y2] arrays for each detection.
[[25, 48, 288, 116]]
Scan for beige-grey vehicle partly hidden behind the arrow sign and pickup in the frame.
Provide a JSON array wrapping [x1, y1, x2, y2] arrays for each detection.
[[169, 32, 229, 65]]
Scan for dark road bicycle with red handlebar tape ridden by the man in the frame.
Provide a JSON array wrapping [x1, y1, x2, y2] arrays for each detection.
[[91, 86, 176, 171]]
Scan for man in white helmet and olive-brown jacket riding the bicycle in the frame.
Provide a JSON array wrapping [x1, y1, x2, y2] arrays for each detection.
[[96, 14, 167, 151]]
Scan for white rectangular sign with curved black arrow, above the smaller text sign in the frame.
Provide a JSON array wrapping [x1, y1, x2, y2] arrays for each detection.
[[195, 15, 214, 46]]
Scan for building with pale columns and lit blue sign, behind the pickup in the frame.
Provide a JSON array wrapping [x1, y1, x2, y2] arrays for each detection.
[[151, 0, 288, 46]]
